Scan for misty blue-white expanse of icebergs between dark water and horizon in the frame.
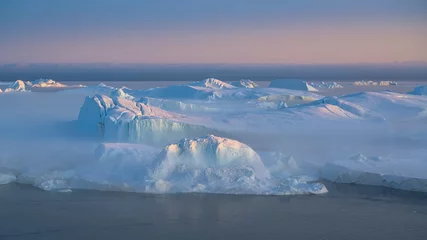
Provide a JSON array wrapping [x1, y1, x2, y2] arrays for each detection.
[[0, 79, 427, 195]]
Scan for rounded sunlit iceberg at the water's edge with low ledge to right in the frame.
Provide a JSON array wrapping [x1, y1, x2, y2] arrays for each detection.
[[149, 135, 327, 195]]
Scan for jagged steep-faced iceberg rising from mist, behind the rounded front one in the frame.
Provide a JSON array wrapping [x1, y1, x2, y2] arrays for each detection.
[[78, 94, 211, 143]]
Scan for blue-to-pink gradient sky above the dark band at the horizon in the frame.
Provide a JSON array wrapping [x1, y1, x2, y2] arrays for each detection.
[[0, 0, 427, 64]]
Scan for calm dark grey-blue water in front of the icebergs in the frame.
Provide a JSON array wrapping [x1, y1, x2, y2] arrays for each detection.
[[0, 183, 427, 240]]
